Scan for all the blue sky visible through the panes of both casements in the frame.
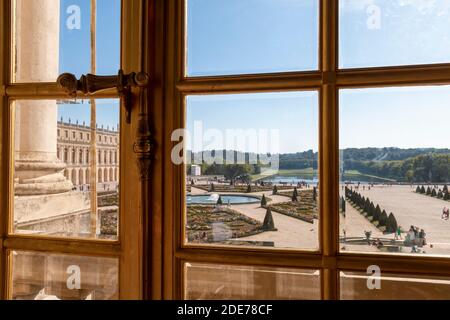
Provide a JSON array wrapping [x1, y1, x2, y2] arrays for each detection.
[[60, 0, 450, 152]]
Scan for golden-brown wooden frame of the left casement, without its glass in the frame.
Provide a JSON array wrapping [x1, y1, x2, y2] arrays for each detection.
[[0, 0, 145, 300]]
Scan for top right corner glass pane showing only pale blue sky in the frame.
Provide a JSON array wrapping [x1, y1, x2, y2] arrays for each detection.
[[339, 0, 450, 68]]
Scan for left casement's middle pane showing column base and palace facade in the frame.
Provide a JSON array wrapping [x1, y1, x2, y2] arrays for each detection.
[[13, 99, 120, 239]]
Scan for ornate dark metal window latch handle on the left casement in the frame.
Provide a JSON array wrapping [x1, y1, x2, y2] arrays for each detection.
[[57, 70, 150, 123]]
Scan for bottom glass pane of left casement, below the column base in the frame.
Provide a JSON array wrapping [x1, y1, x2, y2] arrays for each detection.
[[10, 251, 119, 300]]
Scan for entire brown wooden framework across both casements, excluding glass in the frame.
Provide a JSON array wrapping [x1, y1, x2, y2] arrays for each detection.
[[0, 0, 450, 300]]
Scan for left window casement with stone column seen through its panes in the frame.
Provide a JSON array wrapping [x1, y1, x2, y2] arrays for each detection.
[[0, 0, 145, 300]]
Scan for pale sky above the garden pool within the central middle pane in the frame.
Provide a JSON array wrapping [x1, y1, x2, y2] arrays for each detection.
[[187, 91, 319, 153]]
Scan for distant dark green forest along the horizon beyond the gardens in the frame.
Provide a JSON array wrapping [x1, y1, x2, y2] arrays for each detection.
[[188, 148, 450, 183]]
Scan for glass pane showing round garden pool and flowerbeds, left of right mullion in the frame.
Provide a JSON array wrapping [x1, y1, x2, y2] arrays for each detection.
[[183, 92, 319, 250]]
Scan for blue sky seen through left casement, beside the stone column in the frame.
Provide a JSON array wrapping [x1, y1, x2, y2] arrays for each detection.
[[58, 0, 121, 128]]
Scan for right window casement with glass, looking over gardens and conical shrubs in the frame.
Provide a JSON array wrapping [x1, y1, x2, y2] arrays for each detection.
[[162, 0, 450, 299]]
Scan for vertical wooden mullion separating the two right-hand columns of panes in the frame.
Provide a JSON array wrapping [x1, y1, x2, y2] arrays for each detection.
[[319, 0, 339, 300]]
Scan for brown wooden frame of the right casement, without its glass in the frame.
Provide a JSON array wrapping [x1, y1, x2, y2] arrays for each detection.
[[154, 0, 450, 300]]
